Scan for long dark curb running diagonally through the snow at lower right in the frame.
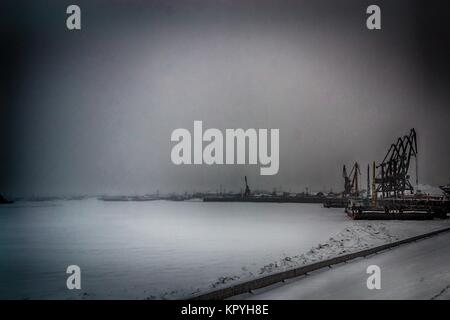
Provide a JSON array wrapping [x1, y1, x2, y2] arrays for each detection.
[[189, 227, 450, 300]]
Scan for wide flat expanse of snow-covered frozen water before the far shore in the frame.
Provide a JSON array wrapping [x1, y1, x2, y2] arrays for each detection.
[[0, 199, 450, 299]]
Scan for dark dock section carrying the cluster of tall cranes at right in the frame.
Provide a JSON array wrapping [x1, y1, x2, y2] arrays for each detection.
[[324, 129, 450, 220]]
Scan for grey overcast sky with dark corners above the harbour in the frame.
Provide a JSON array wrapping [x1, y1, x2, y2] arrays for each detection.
[[0, 0, 450, 196]]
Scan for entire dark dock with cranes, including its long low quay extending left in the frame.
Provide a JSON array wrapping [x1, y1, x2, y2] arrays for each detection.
[[203, 129, 450, 215]]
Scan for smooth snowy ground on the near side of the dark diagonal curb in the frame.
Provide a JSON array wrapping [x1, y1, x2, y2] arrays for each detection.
[[239, 232, 450, 300]]
